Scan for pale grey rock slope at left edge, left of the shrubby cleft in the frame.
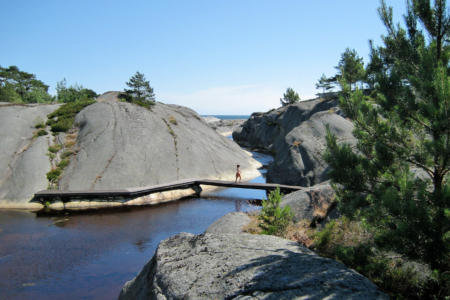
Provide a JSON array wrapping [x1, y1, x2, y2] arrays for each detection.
[[0, 103, 59, 208]]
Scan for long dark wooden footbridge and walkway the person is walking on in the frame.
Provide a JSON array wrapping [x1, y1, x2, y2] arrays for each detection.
[[34, 179, 302, 202]]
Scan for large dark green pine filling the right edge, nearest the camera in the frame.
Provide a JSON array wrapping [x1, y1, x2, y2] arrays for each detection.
[[324, 0, 450, 274]]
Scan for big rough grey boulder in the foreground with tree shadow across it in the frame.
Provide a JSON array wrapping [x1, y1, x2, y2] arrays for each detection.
[[119, 233, 388, 300]]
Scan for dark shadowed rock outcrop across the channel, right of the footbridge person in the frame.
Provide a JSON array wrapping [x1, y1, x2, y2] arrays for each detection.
[[233, 99, 356, 187]]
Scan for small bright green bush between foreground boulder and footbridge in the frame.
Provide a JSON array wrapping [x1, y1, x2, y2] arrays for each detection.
[[258, 187, 293, 236]]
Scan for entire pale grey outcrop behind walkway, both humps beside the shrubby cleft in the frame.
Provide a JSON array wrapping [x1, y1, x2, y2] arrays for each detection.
[[0, 98, 261, 208]]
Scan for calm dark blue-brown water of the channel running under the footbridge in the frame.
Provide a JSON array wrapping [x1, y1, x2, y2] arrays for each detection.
[[0, 149, 271, 300]]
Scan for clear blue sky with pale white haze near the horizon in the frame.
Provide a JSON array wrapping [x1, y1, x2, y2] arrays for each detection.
[[0, 0, 406, 115]]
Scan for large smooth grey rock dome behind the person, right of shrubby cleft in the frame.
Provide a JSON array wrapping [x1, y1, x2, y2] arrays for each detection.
[[60, 102, 260, 190]]
